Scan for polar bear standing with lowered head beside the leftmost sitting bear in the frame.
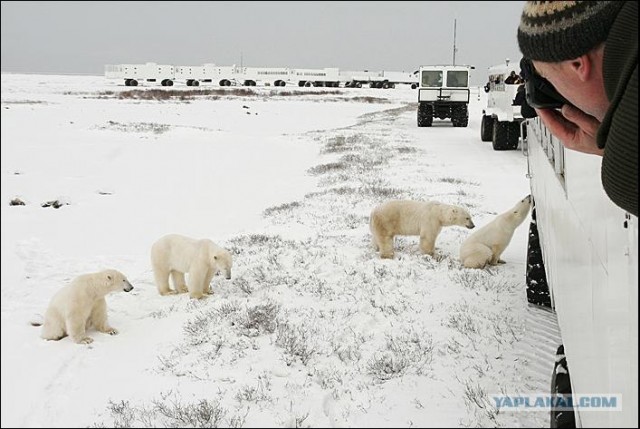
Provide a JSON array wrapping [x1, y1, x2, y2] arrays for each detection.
[[151, 234, 232, 299]]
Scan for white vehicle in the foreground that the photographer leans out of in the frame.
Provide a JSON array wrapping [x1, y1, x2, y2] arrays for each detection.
[[526, 118, 638, 427]]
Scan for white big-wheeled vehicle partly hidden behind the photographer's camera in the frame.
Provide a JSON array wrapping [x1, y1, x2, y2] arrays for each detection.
[[480, 60, 524, 150]]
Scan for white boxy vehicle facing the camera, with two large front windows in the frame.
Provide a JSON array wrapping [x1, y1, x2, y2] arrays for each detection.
[[418, 65, 474, 127]]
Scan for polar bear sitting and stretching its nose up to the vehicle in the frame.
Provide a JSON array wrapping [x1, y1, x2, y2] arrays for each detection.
[[460, 195, 531, 268]]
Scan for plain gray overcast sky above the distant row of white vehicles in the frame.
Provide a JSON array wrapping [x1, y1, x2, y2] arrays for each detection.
[[1, 1, 524, 84]]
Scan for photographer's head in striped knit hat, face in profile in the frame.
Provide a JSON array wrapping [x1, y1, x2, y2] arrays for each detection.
[[518, 1, 624, 120]]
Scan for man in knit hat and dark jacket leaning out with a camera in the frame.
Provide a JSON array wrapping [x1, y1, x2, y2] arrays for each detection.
[[518, 1, 638, 216]]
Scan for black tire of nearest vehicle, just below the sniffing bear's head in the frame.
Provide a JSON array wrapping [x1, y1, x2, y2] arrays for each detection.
[[525, 207, 551, 308]]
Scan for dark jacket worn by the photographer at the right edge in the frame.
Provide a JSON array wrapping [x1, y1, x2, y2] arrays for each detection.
[[597, 1, 638, 216]]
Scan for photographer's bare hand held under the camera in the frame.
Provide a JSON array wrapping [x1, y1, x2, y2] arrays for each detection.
[[536, 104, 604, 156]]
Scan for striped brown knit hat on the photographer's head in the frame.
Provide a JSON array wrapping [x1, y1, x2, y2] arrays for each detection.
[[518, 1, 625, 62]]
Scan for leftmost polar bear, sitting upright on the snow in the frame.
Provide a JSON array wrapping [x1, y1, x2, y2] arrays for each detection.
[[32, 270, 133, 344]]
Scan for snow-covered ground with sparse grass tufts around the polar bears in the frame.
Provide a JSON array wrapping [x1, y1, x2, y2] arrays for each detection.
[[1, 74, 551, 427]]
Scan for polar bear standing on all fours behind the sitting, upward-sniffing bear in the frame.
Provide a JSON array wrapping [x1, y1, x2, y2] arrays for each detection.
[[369, 200, 475, 258]]
